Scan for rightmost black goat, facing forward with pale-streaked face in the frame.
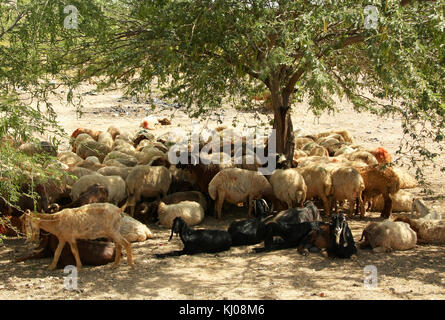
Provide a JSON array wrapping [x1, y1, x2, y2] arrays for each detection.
[[299, 213, 357, 259]]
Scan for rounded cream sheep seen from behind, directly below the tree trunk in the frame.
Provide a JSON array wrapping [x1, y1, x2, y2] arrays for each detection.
[[269, 168, 307, 208]]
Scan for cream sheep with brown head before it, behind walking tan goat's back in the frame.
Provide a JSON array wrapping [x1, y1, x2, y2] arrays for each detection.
[[70, 175, 126, 205]]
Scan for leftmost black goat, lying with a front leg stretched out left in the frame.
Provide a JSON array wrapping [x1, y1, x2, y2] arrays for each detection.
[[156, 217, 232, 258]]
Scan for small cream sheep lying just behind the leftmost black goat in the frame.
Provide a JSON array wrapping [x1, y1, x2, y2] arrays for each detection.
[[158, 201, 204, 228]]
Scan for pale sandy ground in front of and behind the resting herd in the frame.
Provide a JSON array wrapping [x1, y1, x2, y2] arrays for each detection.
[[0, 87, 445, 300]]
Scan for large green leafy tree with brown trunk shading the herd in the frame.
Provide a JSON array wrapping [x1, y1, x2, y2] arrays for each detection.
[[0, 0, 444, 172]]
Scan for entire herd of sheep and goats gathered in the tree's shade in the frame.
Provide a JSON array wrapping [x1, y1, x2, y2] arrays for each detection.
[[0, 122, 445, 269]]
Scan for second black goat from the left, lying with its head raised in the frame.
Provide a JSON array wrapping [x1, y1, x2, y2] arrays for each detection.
[[227, 199, 271, 246]]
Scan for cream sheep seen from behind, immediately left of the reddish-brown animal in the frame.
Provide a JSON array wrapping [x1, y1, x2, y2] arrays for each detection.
[[329, 166, 365, 217]]
